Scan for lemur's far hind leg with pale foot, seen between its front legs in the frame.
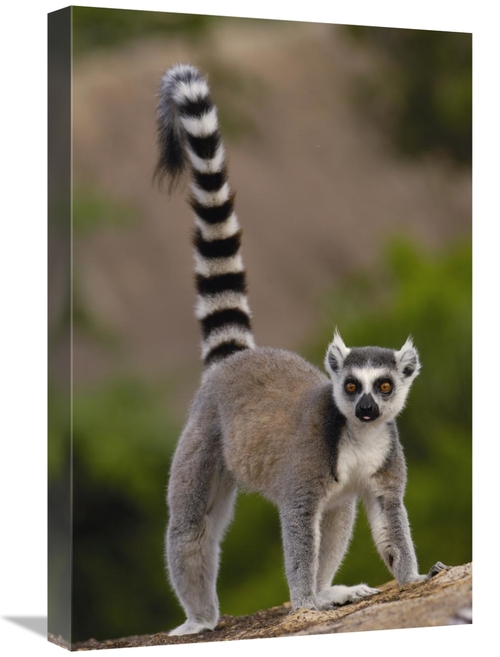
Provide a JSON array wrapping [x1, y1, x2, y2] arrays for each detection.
[[317, 500, 378, 606]]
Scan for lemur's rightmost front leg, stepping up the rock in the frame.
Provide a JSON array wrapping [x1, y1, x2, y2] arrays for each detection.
[[365, 491, 448, 586]]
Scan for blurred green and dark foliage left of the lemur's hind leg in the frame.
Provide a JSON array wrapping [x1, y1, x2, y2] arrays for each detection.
[[60, 376, 186, 641]]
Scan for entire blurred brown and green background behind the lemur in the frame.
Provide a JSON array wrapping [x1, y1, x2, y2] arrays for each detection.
[[49, 8, 472, 641]]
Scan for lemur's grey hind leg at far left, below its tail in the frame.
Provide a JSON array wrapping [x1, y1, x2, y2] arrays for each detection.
[[166, 426, 236, 636]]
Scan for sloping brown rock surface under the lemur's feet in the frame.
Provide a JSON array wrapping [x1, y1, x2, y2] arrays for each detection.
[[63, 563, 472, 650]]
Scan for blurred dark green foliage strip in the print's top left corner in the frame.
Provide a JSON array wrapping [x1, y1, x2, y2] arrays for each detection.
[[72, 7, 213, 56]]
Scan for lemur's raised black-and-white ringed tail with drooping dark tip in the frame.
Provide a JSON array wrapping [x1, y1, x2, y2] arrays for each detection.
[[156, 64, 255, 365]]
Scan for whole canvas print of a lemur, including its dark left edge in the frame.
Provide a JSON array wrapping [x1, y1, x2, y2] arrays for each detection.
[[48, 7, 472, 651]]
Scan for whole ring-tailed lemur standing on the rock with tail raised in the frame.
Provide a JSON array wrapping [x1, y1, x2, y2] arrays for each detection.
[[157, 65, 444, 635]]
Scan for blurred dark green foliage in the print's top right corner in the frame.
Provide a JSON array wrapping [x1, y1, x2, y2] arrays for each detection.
[[344, 26, 472, 165]]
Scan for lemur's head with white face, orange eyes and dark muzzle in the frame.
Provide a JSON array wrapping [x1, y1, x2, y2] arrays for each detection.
[[325, 333, 420, 424]]
